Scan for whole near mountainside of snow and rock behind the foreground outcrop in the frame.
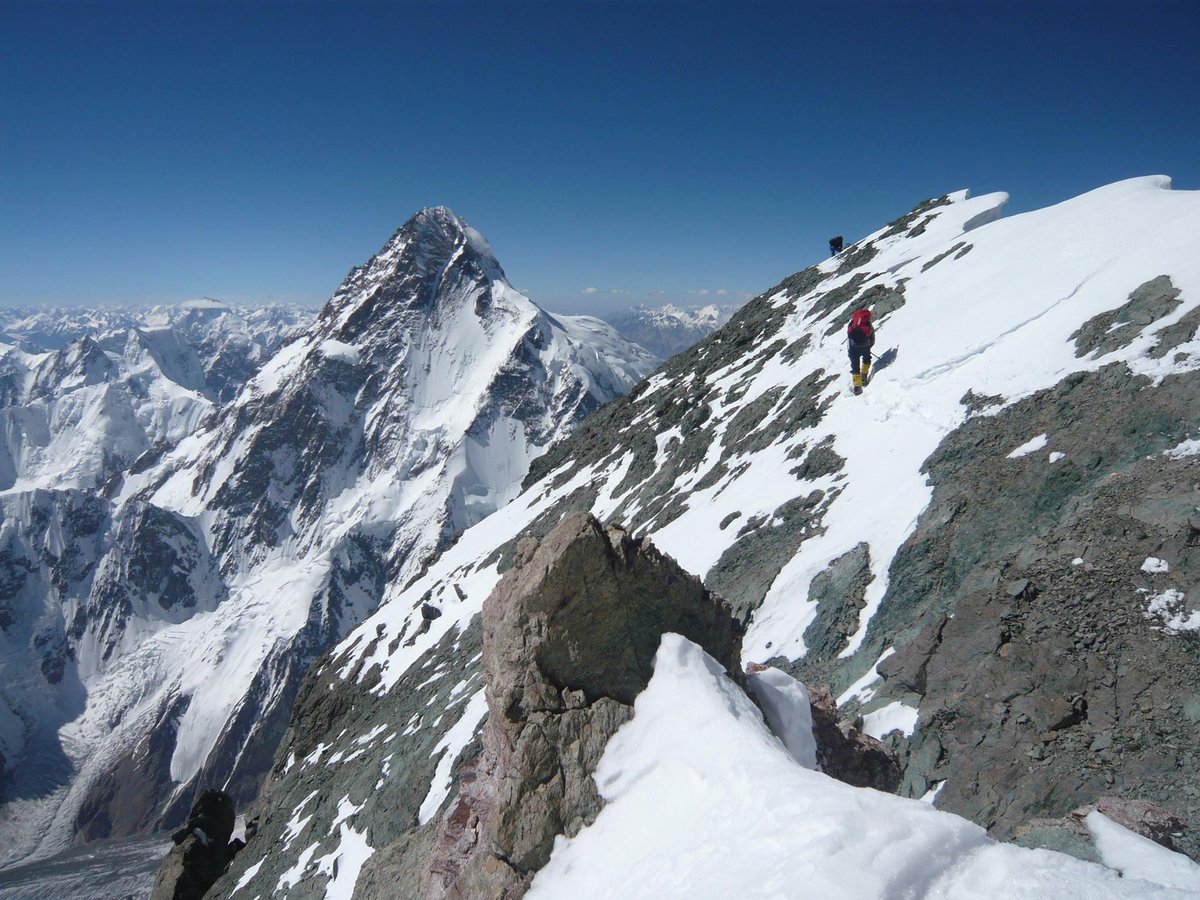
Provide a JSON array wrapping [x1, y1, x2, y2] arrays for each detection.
[[213, 178, 1200, 896]]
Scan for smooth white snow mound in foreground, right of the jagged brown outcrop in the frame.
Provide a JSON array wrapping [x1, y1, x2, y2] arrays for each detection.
[[527, 635, 1200, 900]]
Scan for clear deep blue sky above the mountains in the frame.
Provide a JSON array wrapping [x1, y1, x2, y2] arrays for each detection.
[[0, 0, 1200, 312]]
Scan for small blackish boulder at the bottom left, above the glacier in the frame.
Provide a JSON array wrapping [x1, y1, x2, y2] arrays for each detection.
[[150, 791, 236, 900]]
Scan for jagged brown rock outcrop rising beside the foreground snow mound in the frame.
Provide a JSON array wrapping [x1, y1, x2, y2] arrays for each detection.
[[426, 514, 742, 898]]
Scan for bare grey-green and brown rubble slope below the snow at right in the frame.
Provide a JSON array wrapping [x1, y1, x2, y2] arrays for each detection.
[[816, 365, 1200, 857]]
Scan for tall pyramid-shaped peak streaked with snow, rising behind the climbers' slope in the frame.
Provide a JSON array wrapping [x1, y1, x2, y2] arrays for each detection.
[[0, 209, 654, 858]]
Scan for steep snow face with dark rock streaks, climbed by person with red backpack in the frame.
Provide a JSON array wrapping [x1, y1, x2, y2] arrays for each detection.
[[226, 178, 1200, 893]]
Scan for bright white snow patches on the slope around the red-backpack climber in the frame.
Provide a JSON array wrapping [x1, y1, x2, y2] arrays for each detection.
[[336, 176, 1200, 677]]
